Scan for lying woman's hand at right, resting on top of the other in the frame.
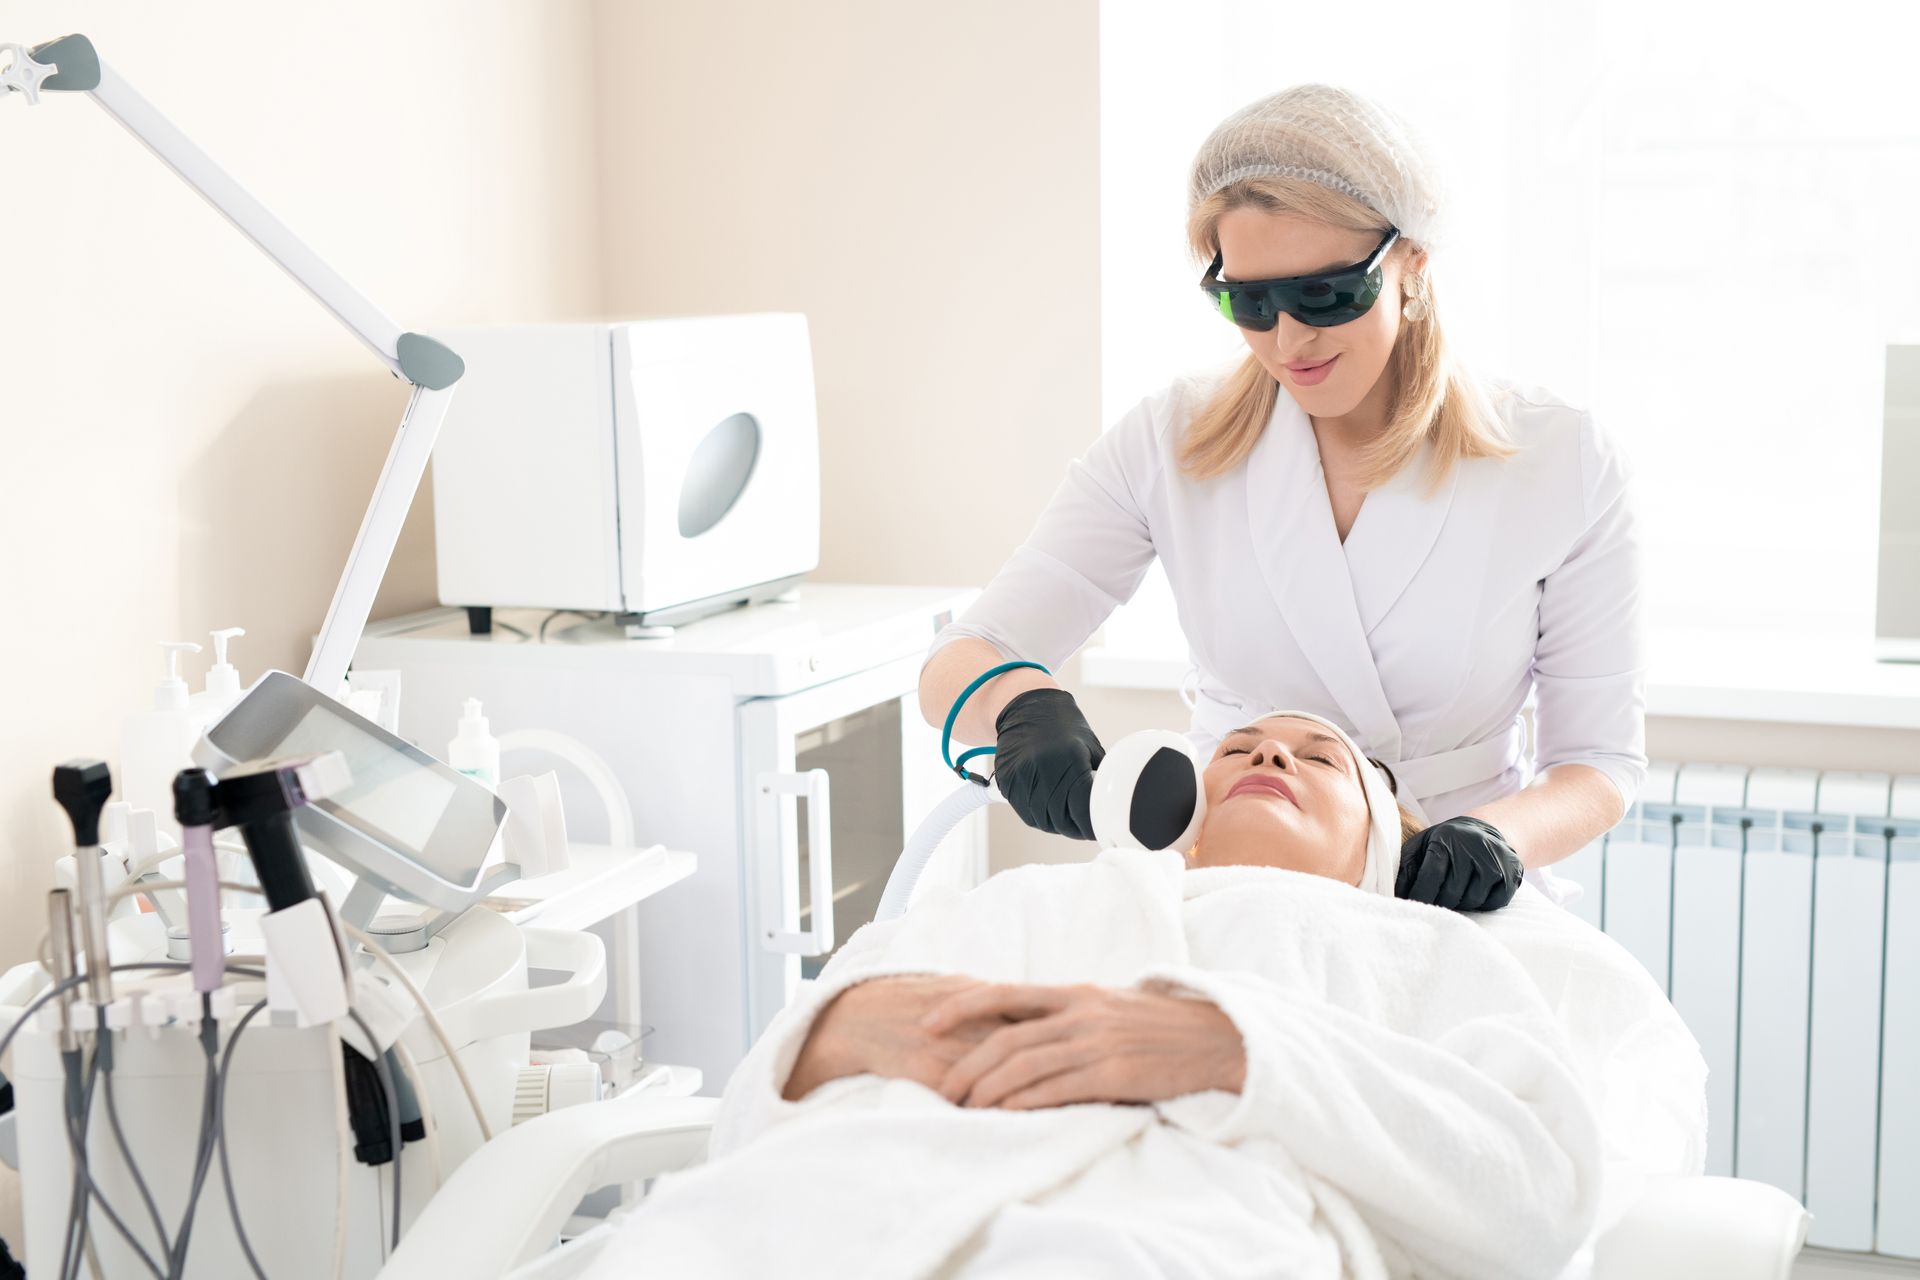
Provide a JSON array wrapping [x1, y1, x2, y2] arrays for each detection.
[[922, 983, 1246, 1111]]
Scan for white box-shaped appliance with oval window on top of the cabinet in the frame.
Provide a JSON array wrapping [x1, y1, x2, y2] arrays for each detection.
[[434, 313, 820, 631]]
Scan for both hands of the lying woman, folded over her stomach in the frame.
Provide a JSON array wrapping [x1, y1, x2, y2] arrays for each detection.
[[789, 977, 1246, 1111]]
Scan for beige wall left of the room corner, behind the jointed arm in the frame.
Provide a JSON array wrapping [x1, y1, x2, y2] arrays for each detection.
[[0, 0, 599, 1240]]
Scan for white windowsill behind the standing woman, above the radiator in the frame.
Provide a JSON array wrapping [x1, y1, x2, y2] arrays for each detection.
[[1081, 629, 1920, 729]]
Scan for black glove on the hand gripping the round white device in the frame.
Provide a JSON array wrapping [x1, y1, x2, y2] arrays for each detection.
[[993, 689, 1106, 841]]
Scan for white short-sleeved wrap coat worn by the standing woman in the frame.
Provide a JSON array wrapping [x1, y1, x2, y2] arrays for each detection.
[[933, 374, 1647, 821]]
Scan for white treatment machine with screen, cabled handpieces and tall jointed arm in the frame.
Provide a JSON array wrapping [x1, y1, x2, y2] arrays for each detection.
[[0, 35, 699, 1280]]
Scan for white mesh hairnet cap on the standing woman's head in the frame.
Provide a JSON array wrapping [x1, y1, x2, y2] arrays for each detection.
[[1187, 84, 1444, 249]]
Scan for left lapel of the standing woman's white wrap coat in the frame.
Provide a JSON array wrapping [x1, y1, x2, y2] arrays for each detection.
[[1246, 391, 1411, 760]]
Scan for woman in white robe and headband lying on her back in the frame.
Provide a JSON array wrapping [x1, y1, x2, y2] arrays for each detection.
[[560, 714, 1705, 1280]]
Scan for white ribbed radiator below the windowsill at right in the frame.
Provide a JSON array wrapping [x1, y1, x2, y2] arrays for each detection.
[[1553, 764, 1920, 1259]]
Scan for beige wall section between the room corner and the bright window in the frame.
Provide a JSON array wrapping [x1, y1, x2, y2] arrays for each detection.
[[597, 0, 1102, 864]]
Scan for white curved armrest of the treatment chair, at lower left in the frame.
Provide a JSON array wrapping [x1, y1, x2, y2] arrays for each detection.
[[380, 1090, 720, 1280]]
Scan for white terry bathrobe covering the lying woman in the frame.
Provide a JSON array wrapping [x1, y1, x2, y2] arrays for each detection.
[[588, 850, 1705, 1280]]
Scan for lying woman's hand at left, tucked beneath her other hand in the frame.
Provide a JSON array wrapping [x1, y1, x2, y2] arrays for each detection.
[[783, 975, 1004, 1102]]
